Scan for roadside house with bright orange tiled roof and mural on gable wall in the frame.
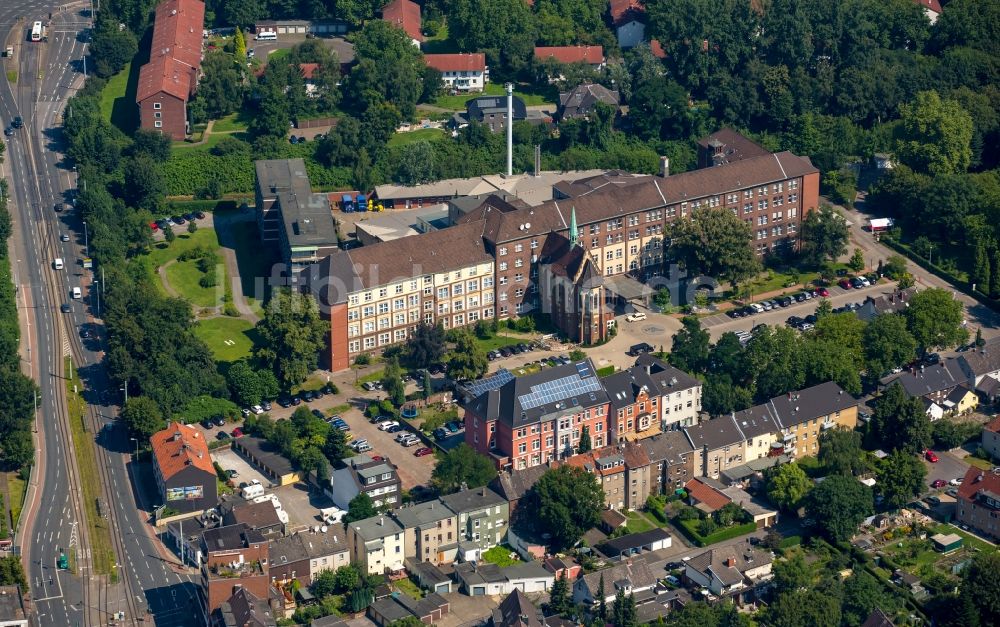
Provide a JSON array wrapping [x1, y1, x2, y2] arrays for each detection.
[[149, 422, 219, 513]]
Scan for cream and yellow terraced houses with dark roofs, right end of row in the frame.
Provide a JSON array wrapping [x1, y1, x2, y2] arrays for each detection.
[[684, 381, 858, 479]]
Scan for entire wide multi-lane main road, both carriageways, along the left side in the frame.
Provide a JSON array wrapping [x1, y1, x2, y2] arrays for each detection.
[[0, 0, 200, 626]]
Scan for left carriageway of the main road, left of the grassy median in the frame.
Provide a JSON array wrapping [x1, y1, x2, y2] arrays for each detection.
[[0, 0, 90, 625]]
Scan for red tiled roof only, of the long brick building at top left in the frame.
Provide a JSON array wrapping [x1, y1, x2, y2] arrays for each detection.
[[136, 0, 205, 102]]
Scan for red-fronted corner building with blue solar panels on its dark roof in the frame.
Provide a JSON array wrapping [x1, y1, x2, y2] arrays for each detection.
[[465, 359, 611, 470]]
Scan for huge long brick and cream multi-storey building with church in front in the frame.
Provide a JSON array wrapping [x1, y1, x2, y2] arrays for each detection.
[[300, 131, 819, 370]]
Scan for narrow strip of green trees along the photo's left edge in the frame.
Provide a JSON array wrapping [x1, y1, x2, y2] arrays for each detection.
[[0, 180, 38, 470]]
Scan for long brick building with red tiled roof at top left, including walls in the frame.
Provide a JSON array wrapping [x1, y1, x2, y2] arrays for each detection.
[[135, 0, 205, 141]]
